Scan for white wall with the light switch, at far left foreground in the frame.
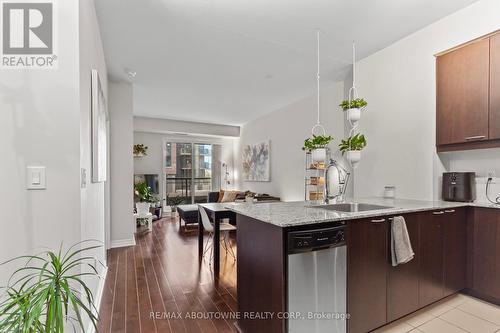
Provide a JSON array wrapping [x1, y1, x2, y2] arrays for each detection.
[[0, 0, 81, 285]]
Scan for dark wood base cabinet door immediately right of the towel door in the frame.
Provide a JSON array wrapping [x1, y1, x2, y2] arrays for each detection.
[[419, 210, 445, 307]]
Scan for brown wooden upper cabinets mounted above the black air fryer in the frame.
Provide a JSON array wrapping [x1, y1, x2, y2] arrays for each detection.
[[436, 35, 500, 151]]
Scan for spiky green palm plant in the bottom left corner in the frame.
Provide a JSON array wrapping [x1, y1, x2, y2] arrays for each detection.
[[0, 241, 101, 333]]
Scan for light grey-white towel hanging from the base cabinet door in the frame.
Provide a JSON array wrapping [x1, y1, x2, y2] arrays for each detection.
[[391, 216, 415, 266]]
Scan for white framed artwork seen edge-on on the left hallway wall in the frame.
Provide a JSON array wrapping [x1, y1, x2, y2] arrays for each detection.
[[91, 69, 108, 183]]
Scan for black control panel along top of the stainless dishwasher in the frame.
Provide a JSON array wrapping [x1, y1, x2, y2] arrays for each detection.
[[288, 226, 346, 254]]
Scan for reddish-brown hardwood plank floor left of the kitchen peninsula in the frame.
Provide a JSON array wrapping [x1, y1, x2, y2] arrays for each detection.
[[98, 218, 237, 333]]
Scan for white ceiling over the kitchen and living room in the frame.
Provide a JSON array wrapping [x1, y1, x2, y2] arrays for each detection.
[[96, 0, 476, 125]]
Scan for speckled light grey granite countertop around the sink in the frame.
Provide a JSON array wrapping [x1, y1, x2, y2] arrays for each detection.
[[226, 198, 500, 227]]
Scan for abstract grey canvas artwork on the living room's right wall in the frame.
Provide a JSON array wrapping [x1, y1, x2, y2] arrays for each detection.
[[243, 141, 271, 182]]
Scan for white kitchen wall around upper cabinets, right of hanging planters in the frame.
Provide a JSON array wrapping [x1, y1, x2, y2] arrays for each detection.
[[355, 0, 500, 199]]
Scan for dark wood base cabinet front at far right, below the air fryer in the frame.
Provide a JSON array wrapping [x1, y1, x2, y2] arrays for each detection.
[[471, 208, 500, 302]]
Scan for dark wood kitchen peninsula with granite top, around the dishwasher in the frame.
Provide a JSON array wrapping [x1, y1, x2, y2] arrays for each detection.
[[229, 198, 500, 333]]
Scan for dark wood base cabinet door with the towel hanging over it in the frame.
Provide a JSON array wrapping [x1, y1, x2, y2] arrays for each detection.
[[387, 213, 422, 322]]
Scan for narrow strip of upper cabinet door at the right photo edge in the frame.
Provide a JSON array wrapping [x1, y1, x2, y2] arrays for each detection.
[[490, 34, 500, 139]]
